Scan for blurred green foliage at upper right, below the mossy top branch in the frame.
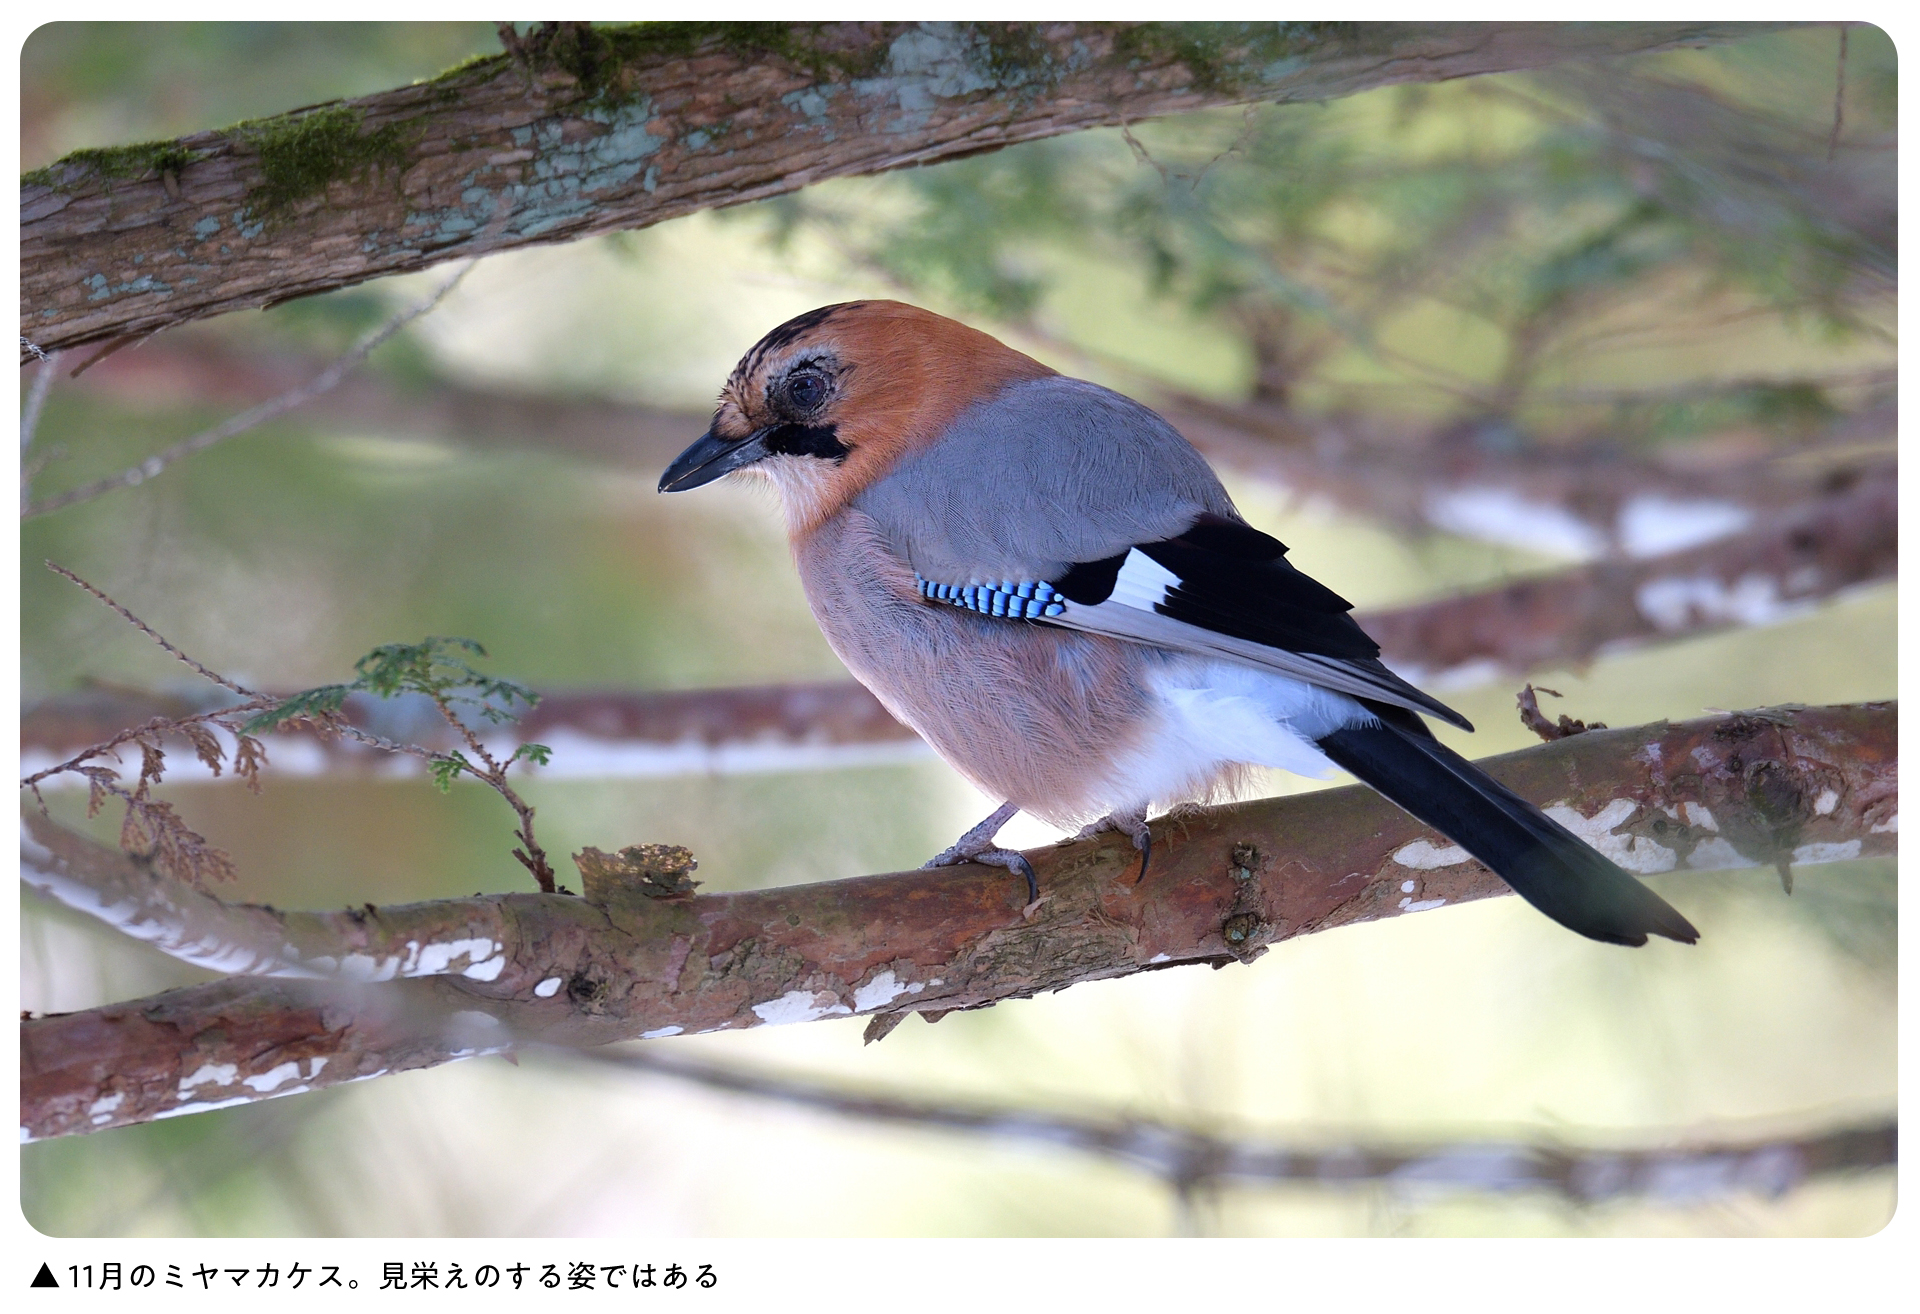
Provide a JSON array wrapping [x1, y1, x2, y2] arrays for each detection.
[[733, 27, 1895, 444]]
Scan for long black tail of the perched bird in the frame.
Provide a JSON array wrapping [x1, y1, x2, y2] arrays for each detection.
[[1319, 701, 1699, 945]]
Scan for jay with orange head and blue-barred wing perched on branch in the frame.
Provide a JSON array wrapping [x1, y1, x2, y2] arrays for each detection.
[[659, 300, 1699, 945]]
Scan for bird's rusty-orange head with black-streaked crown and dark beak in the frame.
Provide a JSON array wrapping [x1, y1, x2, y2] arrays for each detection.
[[660, 302, 1054, 534]]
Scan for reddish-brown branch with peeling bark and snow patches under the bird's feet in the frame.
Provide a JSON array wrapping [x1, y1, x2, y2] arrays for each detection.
[[21, 703, 1899, 1137]]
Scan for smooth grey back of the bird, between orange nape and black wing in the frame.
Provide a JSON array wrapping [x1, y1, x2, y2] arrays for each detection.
[[852, 377, 1238, 584]]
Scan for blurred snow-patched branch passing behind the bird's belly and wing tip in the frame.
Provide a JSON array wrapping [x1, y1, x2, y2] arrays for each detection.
[[21, 480, 1899, 788]]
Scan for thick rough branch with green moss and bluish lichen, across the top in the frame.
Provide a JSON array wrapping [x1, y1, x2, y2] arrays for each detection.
[[21, 23, 1766, 359]]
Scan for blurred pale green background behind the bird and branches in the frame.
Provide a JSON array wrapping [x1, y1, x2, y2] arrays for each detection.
[[21, 23, 1897, 1235]]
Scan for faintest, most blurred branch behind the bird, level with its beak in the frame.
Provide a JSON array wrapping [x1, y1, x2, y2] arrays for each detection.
[[67, 336, 1897, 557]]
